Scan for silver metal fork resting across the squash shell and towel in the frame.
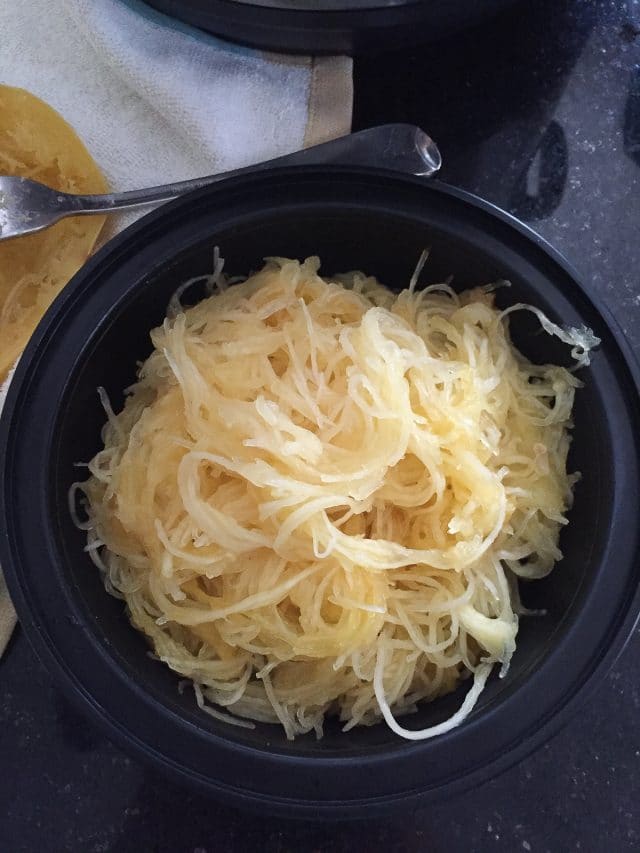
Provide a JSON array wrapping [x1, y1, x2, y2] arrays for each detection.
[[0, 124, 442, 240]]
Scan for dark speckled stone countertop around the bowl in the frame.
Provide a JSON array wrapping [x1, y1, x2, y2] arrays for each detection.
[[0, 0, 640, 853]]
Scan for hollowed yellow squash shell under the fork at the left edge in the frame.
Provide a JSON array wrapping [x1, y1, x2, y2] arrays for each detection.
[[0, 86, 107, 382]]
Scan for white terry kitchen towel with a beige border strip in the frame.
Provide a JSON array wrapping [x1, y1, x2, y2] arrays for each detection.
[[0, 0, 353, 655]]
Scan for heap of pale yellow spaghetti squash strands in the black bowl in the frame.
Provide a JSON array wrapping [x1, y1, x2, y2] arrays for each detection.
[[81, 258, 595, 738]]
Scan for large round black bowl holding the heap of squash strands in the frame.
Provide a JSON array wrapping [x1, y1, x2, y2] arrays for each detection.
[[0, 167, 640, 817]]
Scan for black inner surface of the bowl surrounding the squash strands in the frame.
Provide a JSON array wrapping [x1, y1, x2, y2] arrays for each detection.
[[48, 203, 615, 758]]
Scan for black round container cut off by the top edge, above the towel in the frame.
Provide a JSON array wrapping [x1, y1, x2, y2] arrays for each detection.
[[139, 0, 516, 55]]
